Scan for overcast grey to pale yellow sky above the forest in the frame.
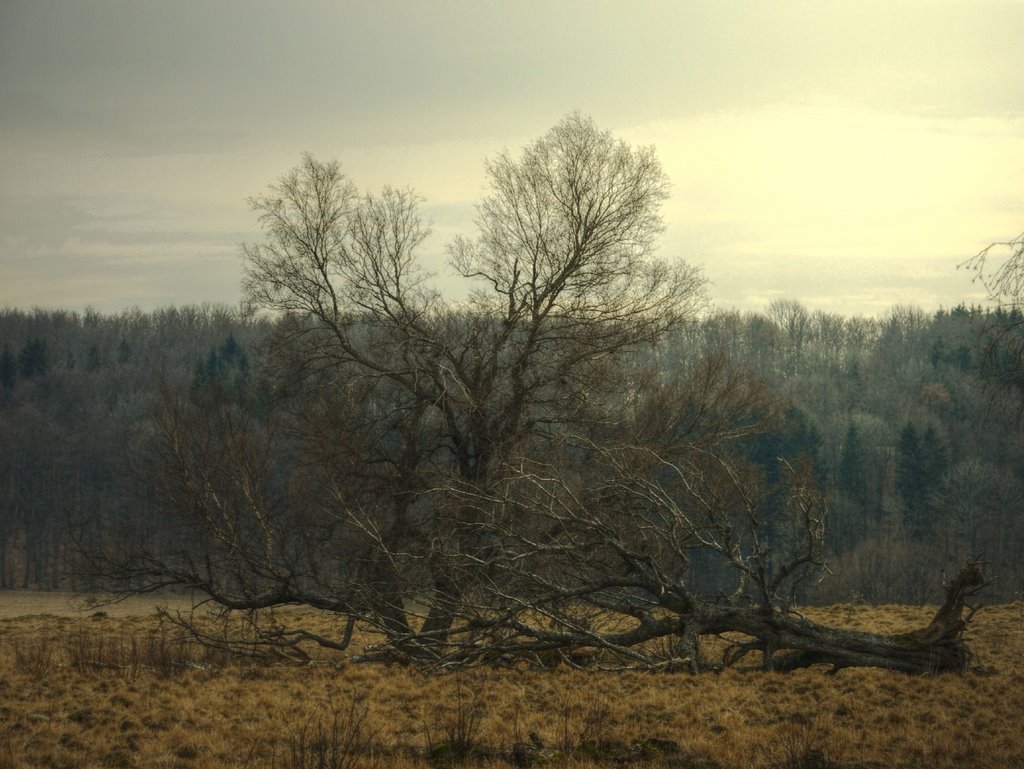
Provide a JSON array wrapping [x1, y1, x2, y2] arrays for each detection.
[[0, 0, 1024, 315]]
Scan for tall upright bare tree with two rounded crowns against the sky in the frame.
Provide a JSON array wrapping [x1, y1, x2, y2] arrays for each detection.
[[99, 115, 703, 645]]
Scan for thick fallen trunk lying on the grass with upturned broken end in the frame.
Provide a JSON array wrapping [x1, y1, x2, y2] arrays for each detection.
[[439, 563, 989, 674]]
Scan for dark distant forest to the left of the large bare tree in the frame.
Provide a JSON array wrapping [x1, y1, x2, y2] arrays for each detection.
[[0, 306, 268, 590]]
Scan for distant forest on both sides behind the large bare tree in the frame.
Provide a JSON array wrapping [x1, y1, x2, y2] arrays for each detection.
[[0, 300, 1024, 602]]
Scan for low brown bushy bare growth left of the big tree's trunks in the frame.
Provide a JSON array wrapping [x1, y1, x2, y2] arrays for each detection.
[[90, 383, 389, 658]]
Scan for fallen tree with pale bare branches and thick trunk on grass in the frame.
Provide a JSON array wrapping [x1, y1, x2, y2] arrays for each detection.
[[405, 428, 989, 673]]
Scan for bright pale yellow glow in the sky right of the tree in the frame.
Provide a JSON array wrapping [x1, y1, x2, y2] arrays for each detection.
[[637, 108, 1024, 314]]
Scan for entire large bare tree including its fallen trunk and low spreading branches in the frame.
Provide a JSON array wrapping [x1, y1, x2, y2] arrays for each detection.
[[99, 114, 977, 670]]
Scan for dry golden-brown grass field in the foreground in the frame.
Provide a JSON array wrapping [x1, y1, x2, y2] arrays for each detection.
[[0, 592, 1024, 769]]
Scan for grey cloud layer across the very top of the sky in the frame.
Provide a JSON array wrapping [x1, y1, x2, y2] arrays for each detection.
[[0, 0, 1024, 152]]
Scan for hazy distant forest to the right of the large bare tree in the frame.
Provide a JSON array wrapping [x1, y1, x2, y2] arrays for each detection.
[[679, 300, 1024, 603]]
